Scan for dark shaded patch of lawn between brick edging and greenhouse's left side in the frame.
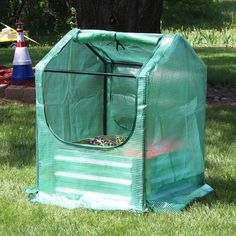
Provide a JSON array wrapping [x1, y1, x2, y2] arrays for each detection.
[[0, 103, 35, 167]]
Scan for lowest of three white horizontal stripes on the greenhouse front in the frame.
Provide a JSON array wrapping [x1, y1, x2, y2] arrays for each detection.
[[56, 187, 131, 201]]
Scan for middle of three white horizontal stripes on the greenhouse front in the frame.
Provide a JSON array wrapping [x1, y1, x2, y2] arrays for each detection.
[[55, 171, 132, 185]]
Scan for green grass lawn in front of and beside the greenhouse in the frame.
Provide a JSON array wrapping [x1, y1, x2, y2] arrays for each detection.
[[0, 103, 236, 236]]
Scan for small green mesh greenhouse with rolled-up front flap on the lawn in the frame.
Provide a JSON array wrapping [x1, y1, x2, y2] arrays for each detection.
[[28, 29, 212, 212]]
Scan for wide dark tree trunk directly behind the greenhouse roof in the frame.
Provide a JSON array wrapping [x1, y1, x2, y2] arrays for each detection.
[[73, 0, 163, 33]]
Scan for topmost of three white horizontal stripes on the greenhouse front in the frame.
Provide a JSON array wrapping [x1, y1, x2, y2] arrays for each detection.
[[55, 156, 132, 169]]
